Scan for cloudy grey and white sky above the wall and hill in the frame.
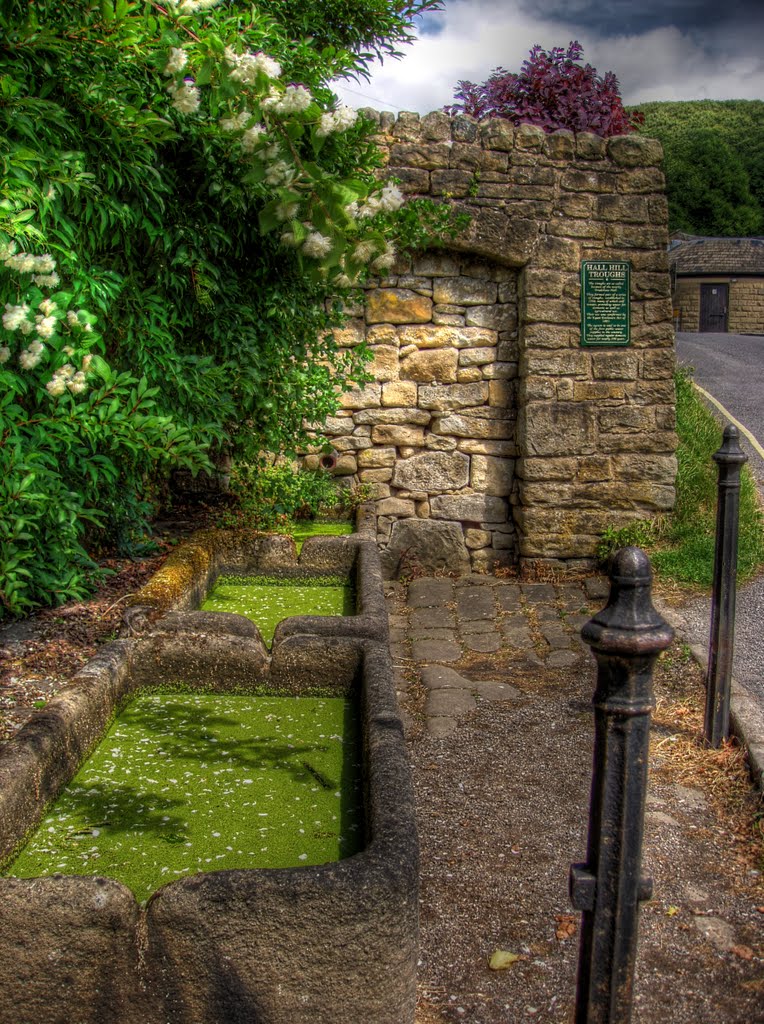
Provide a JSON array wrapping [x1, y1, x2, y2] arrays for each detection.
[[336, 0, 764, 114]]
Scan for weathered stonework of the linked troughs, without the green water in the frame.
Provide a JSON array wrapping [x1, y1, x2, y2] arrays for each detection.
[[0, 538, 418, 1024]]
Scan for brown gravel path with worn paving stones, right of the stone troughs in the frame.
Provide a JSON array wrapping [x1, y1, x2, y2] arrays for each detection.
[[388, 577, 764, 1024]]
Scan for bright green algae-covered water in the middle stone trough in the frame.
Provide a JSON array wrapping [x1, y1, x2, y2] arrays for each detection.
[[202, 577, 355, 645]]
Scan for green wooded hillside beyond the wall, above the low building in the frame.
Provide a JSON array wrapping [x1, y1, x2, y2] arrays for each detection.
[[640, 99, 764, 236]]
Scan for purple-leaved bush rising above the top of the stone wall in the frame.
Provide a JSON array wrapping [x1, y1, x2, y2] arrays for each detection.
[[445, 42, 641, 137]]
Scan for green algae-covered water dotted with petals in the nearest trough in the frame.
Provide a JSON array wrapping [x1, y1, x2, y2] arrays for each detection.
[[4, 693, 365, 900]]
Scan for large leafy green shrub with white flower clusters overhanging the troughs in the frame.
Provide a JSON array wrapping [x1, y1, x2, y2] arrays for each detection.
[[0, 0, 448, 616]]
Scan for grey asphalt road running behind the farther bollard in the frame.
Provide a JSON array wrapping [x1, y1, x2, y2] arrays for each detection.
[[677, 334, 764, 724]]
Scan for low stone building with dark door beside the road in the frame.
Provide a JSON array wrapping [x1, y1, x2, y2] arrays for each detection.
[[669, 236, 764, 334]]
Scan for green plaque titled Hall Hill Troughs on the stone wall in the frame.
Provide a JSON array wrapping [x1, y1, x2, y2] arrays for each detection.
[[581, 259, 631, 345]]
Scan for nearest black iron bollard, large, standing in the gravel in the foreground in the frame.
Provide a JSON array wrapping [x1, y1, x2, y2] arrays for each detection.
[[570, 548, 674, 1024]]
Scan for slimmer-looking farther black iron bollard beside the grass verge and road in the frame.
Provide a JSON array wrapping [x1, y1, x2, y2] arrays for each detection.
[[703, 424, 748, 746]]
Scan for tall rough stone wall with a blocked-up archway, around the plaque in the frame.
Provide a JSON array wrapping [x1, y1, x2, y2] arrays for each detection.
[[308, 111, 676, 575]]
